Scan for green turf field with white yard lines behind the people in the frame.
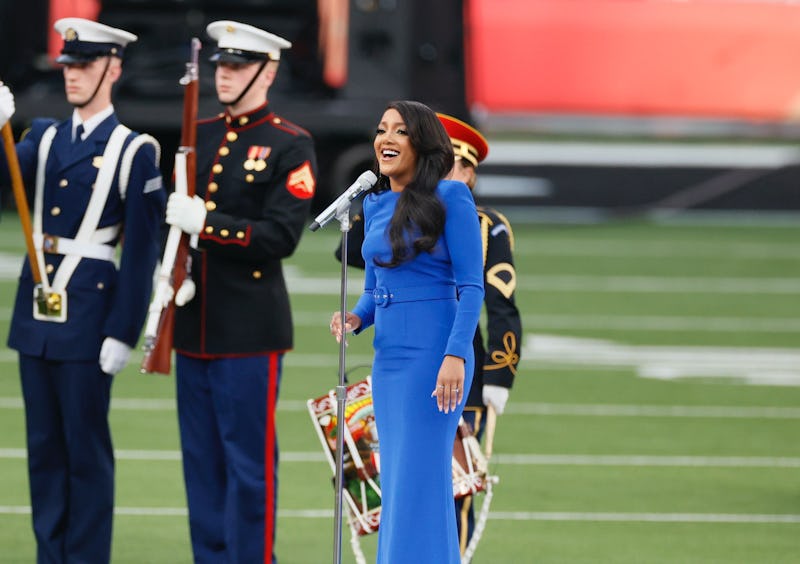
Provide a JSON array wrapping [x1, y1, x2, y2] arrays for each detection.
[[0, 209, 800, 564]]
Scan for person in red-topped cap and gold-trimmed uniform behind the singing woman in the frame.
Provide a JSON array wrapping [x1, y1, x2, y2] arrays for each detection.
[[335, 113, 522, 554]]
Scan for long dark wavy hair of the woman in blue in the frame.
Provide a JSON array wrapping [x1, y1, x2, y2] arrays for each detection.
[[375, 100, 454, 268]]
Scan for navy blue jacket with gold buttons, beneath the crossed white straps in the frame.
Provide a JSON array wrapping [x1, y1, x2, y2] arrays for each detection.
[[0, 115, 166, 361]]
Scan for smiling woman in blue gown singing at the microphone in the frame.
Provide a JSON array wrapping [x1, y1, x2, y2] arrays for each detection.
[[331, 101, 483, 564]]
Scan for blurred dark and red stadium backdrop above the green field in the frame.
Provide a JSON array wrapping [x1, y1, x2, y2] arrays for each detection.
[[0, 0, 800, 220]]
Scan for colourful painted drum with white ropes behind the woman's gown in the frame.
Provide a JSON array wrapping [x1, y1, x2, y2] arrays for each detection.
[[307, 377, 488, 536]]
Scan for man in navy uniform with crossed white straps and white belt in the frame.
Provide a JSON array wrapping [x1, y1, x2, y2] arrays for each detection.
[[0, 18, 166, 562]]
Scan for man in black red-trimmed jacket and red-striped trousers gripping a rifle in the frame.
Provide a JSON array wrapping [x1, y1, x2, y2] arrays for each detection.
[[167, 21, 317, 563]]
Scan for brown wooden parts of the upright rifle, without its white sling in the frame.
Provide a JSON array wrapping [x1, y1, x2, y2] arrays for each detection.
[[140, 38, 200, 374]]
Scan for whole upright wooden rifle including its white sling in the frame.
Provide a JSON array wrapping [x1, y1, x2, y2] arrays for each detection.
[[140, 37, 200, 374]]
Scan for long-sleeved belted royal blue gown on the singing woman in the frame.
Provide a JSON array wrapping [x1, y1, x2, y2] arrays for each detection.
[[353, 180, 483, 564]]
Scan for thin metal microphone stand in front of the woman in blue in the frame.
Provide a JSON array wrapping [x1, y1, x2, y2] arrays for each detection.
[[333, 201, 350, 564]]
